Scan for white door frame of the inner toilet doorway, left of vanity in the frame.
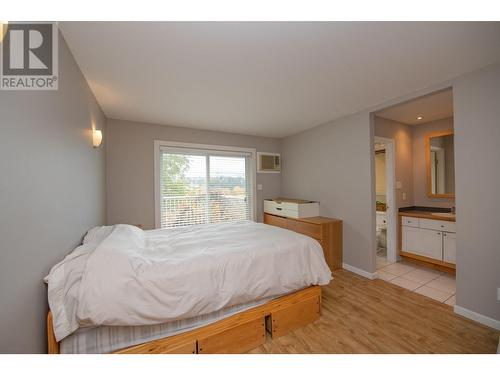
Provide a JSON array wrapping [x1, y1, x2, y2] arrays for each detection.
[[374, 136, 398, 262]]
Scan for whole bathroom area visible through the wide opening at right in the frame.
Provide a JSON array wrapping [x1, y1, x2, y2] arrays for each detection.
[[374, 89, 456, 306]]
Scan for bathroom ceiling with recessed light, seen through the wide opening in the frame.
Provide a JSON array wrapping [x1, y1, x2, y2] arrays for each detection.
[[375, 89, 453, 125]]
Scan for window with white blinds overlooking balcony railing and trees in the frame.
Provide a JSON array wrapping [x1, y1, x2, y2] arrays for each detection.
[[155, 141, 255, 228]]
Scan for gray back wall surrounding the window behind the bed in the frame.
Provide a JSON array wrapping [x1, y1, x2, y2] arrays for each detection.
[[107, 120, 281, 229]]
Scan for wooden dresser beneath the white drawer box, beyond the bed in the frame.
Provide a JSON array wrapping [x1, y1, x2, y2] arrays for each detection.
[[264, 213, 342, 271]]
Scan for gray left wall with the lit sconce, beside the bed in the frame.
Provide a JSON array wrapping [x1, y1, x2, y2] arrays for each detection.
[[0, 33, 106, 353]]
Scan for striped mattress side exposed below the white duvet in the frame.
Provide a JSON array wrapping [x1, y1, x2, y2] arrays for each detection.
[[59, 296, 279, 354]]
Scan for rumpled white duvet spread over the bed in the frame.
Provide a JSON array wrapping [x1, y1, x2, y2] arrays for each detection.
[[47, 221, 331, 341]]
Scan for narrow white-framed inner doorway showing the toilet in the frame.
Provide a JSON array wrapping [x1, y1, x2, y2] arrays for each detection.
[[374, 137, 397, 266]]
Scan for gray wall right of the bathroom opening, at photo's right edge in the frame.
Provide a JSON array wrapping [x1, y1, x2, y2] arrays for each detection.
[[453, 64, 500, 327]]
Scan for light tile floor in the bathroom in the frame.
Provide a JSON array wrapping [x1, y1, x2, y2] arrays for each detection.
[[377, 256, 456, 306]]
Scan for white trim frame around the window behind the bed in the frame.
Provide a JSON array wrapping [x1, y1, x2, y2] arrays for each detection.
[[154, 139, 257, 229]]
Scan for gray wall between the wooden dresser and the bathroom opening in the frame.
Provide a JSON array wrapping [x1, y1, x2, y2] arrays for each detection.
[[282, 112, 375, 273]]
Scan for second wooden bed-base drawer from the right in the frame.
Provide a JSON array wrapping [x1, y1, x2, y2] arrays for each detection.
[[198, 317, 266, 354]]
